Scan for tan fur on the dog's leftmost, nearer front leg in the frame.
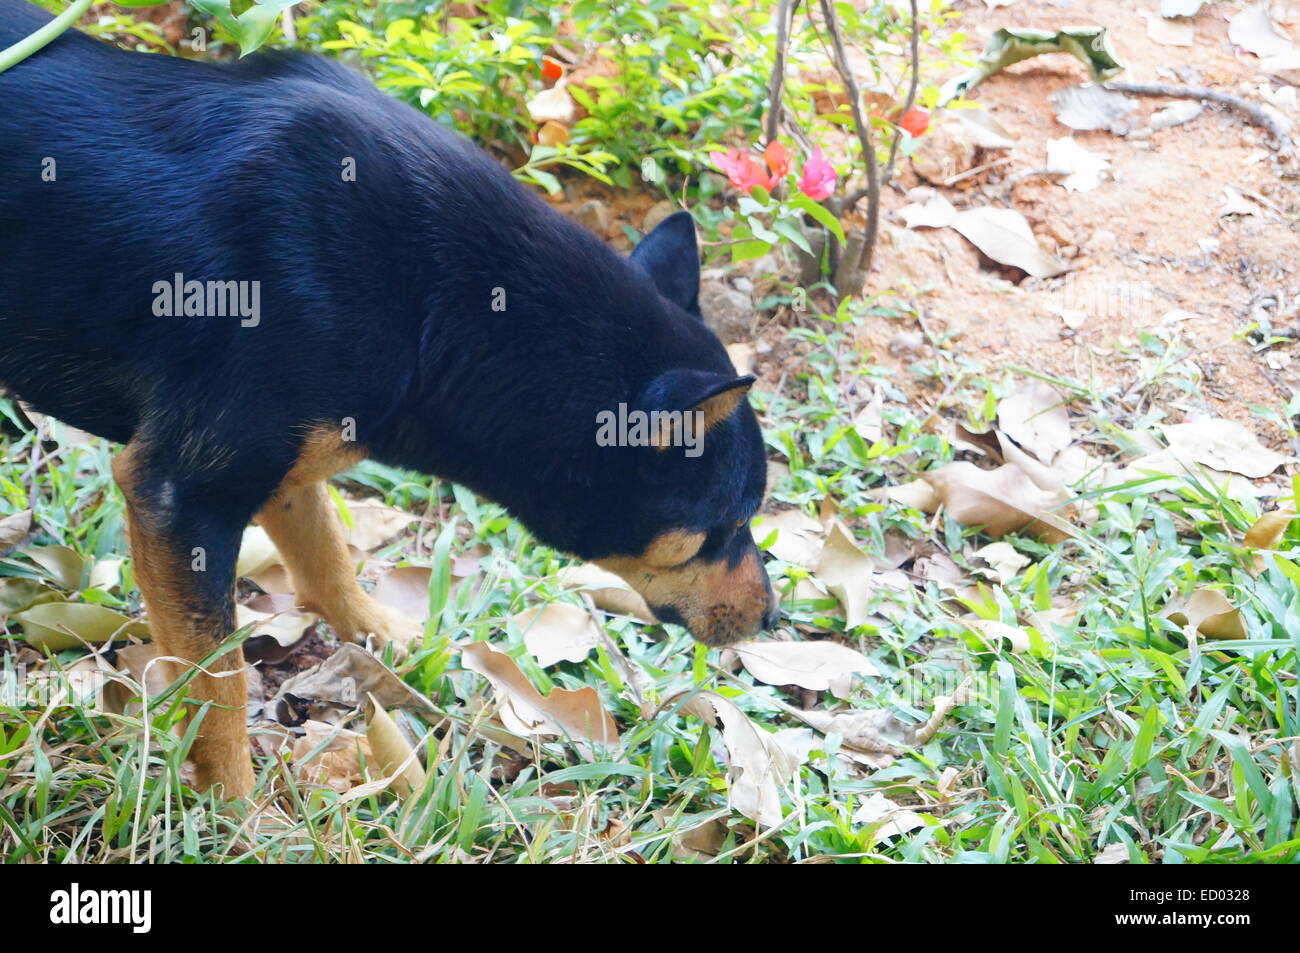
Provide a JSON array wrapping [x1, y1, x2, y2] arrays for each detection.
[[113, 446, 254, 797]]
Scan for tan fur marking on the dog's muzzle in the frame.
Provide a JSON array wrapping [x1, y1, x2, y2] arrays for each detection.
[[595, 534, 771, 645]]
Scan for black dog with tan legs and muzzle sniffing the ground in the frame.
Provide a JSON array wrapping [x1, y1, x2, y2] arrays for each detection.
[[0, 0, 775, 794]]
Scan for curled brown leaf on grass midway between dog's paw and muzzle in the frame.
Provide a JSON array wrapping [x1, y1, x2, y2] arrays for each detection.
[[460, 642, 619, 753]]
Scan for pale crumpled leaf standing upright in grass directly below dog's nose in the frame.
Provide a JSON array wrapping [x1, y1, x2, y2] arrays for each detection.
[[681, 692, 798, 827]]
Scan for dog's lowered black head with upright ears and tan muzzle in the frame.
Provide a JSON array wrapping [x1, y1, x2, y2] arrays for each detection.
[[595, 212, 776, 645]]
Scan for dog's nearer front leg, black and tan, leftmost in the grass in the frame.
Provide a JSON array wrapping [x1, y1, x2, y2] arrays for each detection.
[[113, 442, 256, 797]]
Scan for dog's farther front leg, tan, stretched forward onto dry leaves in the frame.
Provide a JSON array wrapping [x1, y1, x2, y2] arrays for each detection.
[[257, 478, 419, 646]]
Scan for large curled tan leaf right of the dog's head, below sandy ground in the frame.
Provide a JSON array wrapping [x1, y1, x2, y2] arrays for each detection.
[[922, 460, 1075, 542]]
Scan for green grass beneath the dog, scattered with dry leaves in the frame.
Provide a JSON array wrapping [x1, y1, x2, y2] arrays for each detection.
[[0, 308, 1300, 863]]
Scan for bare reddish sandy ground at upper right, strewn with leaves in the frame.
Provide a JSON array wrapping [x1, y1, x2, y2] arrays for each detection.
[[862, 0, 1300, 419]]
